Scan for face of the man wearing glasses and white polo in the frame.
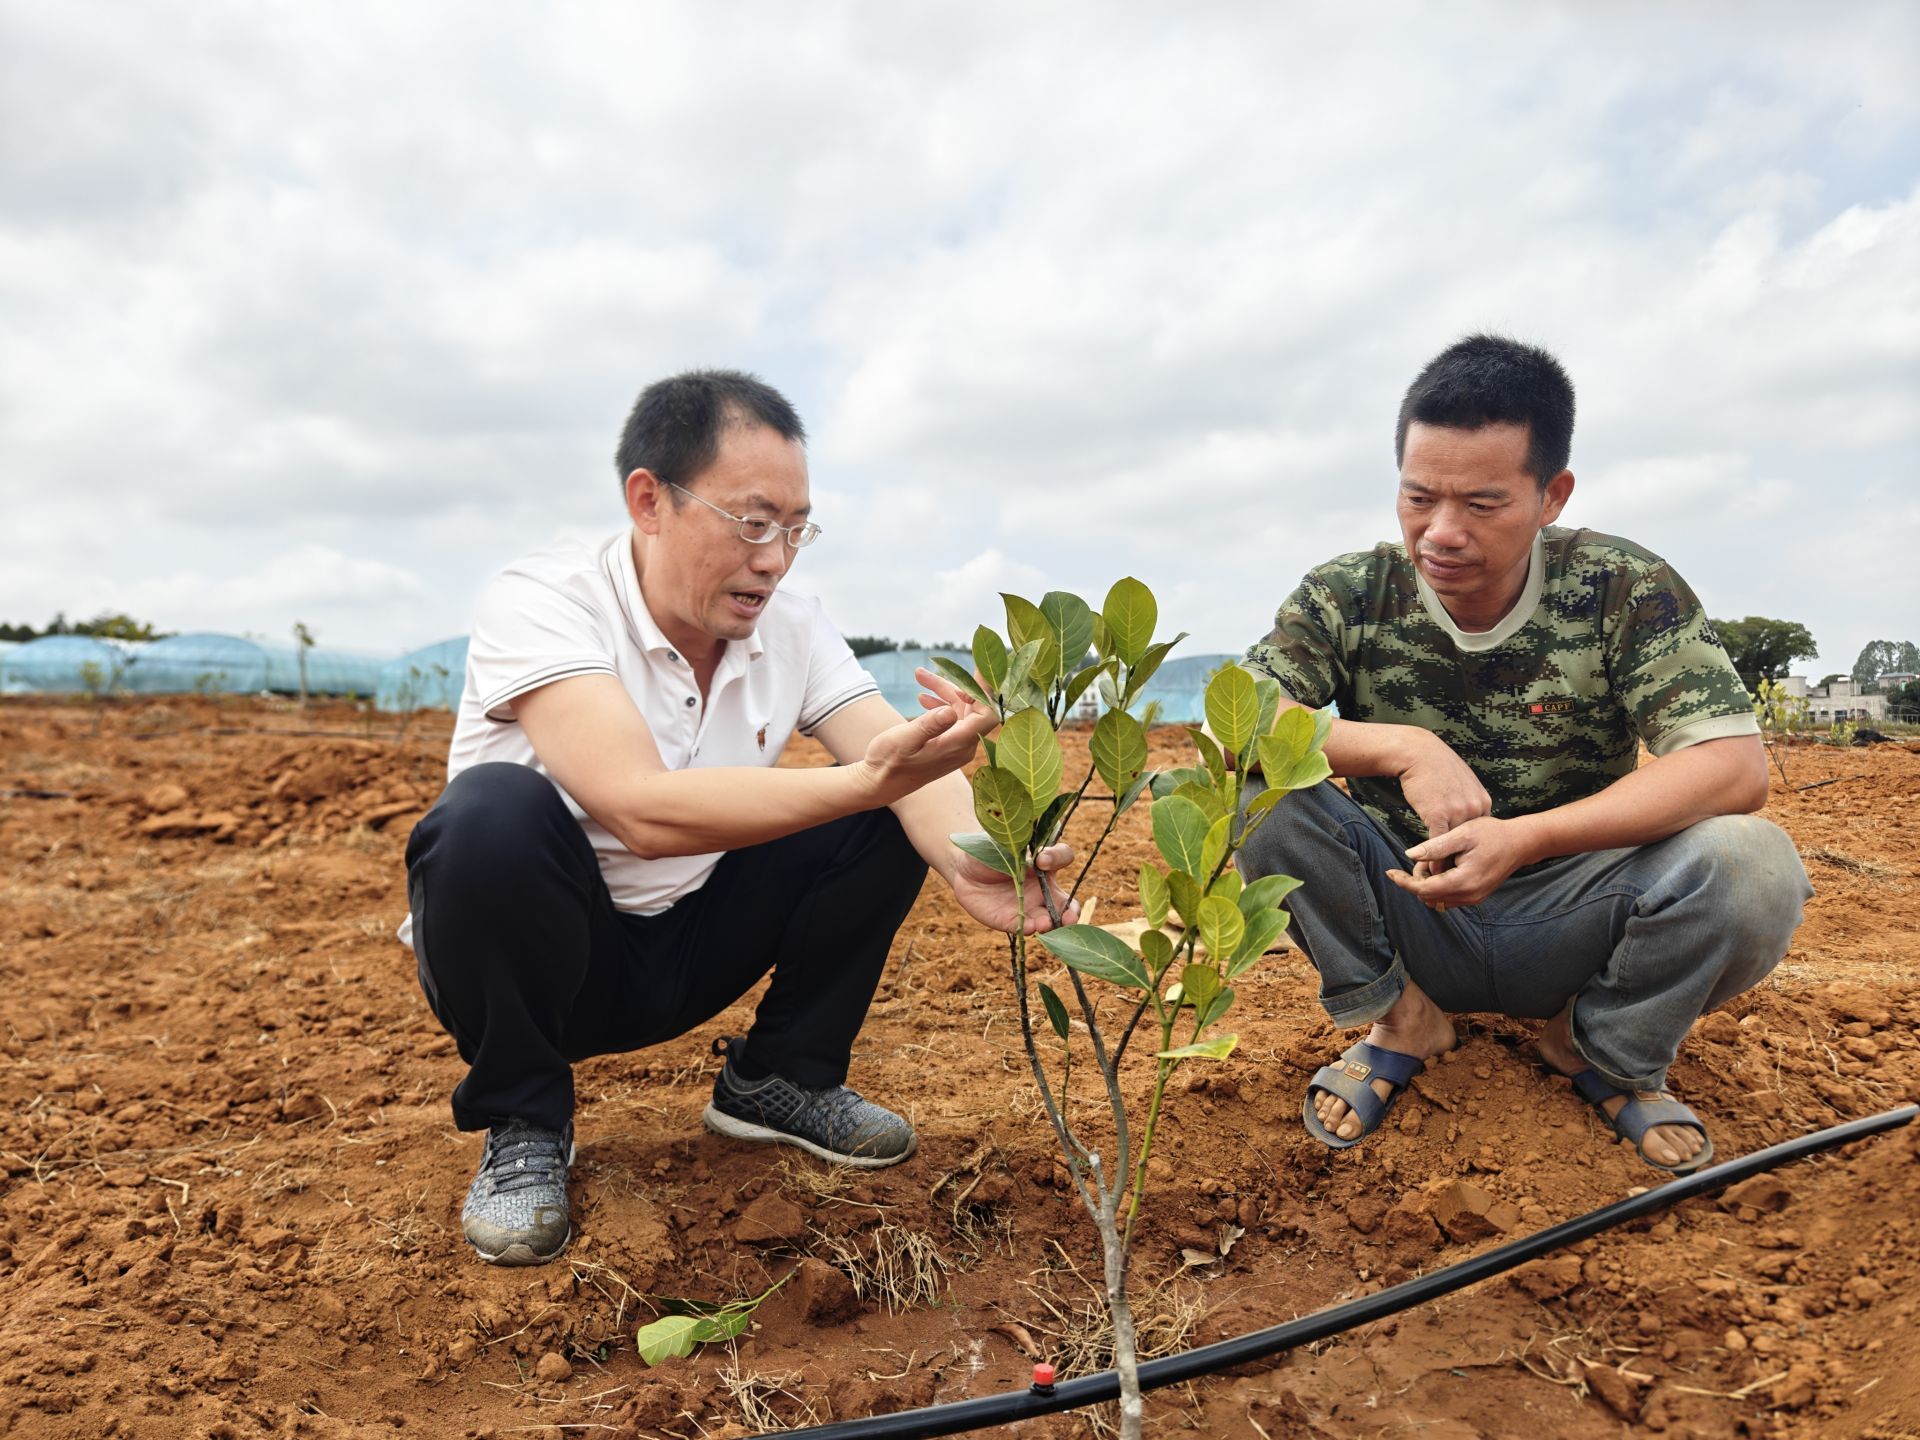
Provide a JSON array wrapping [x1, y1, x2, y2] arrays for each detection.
[[626, 424, 810, 653]]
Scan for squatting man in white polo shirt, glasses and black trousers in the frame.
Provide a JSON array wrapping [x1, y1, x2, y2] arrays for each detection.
[[403, 371, 1071, 1265]]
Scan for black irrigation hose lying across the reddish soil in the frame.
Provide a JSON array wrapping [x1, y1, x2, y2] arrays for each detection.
[[760, 1106, 1920, 1440]]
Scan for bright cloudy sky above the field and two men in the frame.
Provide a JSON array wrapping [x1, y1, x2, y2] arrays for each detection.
[[0, 0, 1920, 676]]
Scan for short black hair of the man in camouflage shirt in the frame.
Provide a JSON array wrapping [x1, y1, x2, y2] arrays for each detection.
[[1394, 334, 1572, 486]]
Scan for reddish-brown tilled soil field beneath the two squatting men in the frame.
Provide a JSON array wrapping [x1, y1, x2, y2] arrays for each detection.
[[0, 701, 1920, 1440]]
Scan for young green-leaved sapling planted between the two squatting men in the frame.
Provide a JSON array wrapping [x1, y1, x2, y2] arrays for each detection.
[[935, 578, 1331, 1440]]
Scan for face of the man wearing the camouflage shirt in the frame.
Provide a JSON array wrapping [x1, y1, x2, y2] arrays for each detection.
[[1396, 422, 1572, 630]]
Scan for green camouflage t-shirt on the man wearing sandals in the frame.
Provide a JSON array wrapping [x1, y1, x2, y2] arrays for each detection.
[[1246, 526, 1759, 845]]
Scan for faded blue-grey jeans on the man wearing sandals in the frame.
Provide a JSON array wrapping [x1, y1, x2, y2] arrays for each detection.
[[1238, 780, 1812, 1091]]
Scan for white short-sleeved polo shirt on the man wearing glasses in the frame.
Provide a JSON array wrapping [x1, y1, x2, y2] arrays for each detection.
[[416, 530, 879, 925]]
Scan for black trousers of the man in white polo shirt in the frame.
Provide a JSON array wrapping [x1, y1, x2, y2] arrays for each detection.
[[407, 764, 927, 1131]]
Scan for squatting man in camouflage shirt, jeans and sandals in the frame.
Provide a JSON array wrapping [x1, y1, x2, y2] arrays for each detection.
[[1240, 336, 1812, 1171]]
